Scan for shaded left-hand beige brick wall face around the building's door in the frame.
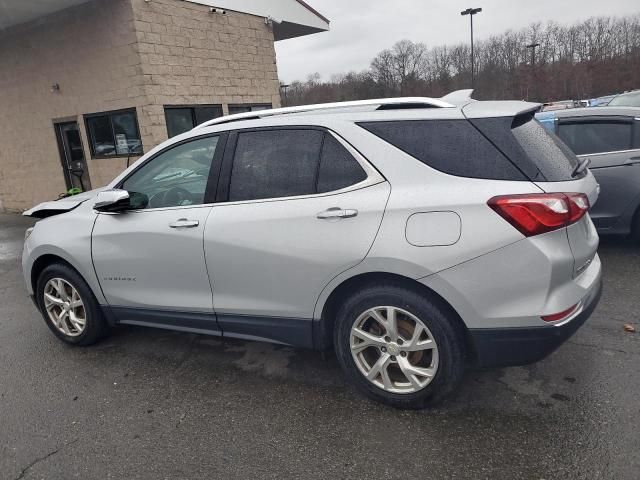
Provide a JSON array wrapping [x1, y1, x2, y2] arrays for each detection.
[[0, 0, 141, 210]]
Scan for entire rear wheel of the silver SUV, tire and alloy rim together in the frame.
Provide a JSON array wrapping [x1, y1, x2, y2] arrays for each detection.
[[334, 284, 465, 409]]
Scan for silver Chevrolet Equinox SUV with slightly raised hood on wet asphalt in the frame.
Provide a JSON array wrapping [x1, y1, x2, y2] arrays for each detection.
[[23, 92, 601, 408]]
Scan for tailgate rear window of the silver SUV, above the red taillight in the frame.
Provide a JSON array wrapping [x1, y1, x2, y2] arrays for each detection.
[[471, 114, 586, 182]]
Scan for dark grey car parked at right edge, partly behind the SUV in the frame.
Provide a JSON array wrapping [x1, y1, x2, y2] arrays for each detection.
[[537, 106, 640, 241]]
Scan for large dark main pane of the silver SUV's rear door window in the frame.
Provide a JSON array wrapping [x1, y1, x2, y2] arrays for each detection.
[[229, 129, 324, 202]]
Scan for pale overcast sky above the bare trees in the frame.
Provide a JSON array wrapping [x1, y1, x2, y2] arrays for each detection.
[[276, 0, 640, 83]]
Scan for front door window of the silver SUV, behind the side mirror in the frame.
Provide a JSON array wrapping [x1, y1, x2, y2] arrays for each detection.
[[121, 136, 219, 208]]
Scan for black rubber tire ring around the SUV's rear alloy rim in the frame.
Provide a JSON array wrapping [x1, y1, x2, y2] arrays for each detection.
[[334, 286, 465, 409]]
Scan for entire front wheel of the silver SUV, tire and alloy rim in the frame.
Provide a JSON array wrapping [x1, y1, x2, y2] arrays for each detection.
[[36, 263, 109, 346]]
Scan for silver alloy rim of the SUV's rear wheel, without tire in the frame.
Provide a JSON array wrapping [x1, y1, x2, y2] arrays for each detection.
[[349, 306, 438, 394]]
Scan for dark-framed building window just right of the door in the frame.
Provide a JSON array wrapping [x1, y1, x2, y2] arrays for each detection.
[[84, 109, 142, 158]]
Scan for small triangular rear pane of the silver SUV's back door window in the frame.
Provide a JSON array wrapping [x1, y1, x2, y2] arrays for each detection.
[[318, 134, 367, 193]]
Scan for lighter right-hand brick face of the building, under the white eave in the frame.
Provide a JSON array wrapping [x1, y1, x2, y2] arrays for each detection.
[[132, 0, 280, 145]]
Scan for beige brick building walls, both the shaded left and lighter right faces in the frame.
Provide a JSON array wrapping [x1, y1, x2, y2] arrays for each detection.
[[0, 0, 280, 210]]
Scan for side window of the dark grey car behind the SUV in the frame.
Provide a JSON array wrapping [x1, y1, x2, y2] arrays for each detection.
[[558, 120, 632, 155]]
